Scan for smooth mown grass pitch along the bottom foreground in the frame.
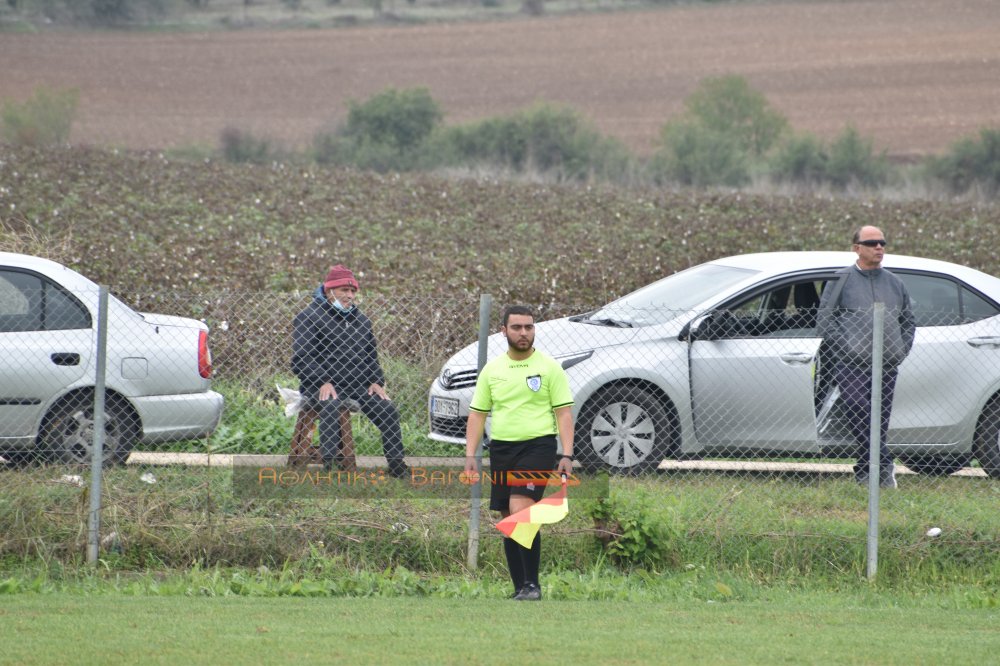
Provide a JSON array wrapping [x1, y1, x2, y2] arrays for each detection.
[[0, 593, 1000, 665]]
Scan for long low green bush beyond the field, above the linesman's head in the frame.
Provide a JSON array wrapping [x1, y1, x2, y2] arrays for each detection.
[[426, 102, 631, 181]]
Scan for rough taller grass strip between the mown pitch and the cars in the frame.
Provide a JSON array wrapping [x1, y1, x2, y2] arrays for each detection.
[[0, 466, 1000, 588]]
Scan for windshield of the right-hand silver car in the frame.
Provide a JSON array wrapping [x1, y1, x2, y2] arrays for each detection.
[[574, 264, 758, 328]]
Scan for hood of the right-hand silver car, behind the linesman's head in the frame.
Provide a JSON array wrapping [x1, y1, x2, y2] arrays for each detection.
[[447, 318, 641, 368]]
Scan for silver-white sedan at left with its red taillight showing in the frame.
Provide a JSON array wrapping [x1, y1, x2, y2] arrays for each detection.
[[0, 253, 223, 462]]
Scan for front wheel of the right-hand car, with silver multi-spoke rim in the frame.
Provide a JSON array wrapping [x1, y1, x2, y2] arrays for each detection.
[[575, 386, 676, 474]]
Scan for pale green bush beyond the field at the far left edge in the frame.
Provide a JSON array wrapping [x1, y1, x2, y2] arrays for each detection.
[[0, 87, 79, 146]]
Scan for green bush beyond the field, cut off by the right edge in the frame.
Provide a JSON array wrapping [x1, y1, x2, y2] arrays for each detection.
[[927, 128, 1000, 197]]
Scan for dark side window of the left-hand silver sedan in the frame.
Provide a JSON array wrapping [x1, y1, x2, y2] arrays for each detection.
[[0, 270, 91, 333]]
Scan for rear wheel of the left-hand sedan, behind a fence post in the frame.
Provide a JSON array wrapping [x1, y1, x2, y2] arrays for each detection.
[[41, 394, 139, 464]]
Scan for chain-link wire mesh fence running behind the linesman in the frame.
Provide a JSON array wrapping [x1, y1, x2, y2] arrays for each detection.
[[0, 272, 1000, 569]]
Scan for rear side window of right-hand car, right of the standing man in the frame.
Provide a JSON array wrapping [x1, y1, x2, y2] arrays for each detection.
[[898, 273, 1000, 326]]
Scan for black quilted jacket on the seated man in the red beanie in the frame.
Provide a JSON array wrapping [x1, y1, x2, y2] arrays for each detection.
[[292, 287, 385, 399]]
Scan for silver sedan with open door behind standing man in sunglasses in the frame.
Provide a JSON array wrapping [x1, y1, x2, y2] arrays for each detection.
[[428, 252, 1000, 477]]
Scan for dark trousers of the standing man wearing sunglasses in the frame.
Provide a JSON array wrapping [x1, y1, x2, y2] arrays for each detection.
[[836, 364, 899, 476]]
